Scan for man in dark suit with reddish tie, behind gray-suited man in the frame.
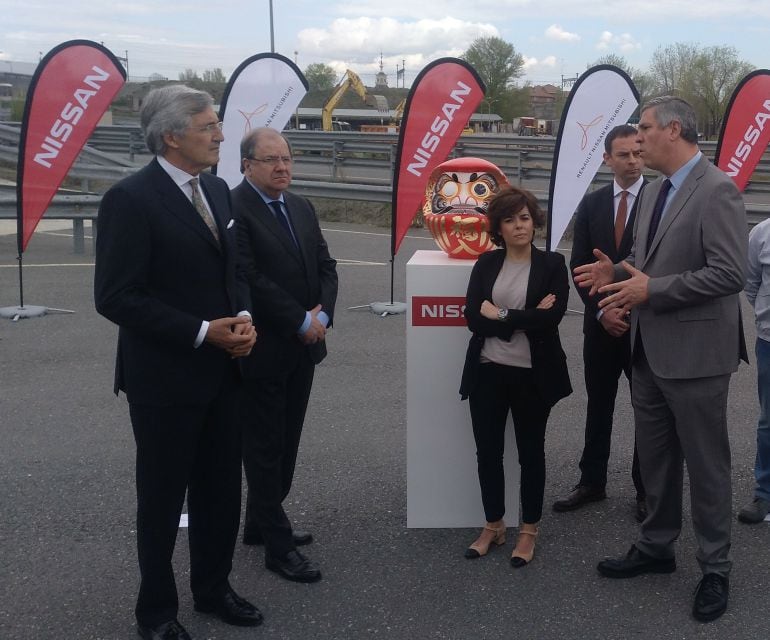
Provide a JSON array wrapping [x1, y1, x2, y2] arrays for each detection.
[[553, 124, 647, 522]]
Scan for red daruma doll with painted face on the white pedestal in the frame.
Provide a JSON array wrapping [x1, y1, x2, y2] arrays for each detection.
[[422, 158, 508, 260]]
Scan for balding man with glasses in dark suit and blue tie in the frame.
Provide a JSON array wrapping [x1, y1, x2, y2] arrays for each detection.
[[232, 128, 337, 582]]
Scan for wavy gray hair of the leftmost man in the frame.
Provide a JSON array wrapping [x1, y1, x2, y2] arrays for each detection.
[[139, 84, 214, 155]]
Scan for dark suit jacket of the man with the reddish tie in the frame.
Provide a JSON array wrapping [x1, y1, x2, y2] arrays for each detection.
[[569, 179, 647, 333]]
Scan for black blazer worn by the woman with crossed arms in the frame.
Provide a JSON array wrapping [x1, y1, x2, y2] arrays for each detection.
[[460, 246, 572, 407]]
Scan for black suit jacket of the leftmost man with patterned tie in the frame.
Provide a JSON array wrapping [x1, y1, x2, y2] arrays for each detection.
[[94, 160, 248, 405]]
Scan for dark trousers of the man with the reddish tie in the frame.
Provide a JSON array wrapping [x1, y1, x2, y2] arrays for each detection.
[[580, 330, 645, 499]]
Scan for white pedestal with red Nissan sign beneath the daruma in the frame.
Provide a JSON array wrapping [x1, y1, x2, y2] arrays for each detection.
[[406, 251, 519, 527]]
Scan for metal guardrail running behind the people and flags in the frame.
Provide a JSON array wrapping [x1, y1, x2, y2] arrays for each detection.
[[0, 124, 770, 251]]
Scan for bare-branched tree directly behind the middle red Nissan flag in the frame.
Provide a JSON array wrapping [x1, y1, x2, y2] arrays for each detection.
[[462, 36, 524, 114]]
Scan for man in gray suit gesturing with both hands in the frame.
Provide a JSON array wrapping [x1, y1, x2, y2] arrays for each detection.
[[575, 96, 748, 622]]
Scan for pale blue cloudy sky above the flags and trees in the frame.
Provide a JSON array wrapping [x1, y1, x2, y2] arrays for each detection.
[[0, 0, 770, 86]]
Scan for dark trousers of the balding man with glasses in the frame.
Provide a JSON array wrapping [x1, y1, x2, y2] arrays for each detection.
[[243, 355, 315, 557]]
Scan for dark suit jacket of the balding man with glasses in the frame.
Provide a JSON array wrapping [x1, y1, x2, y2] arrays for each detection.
[[232, 179, 337, 378]]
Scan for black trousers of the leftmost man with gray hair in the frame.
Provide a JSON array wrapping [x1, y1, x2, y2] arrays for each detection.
[[129, 372, 241, 626]]
